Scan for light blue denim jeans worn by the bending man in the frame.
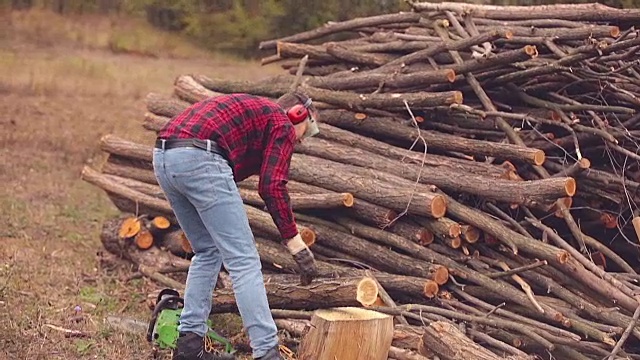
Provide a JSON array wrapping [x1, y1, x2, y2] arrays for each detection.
[[153, 148, 278, 357]]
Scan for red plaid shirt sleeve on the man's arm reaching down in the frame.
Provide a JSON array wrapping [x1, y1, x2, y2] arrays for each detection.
[[258, 124, 298, 239]]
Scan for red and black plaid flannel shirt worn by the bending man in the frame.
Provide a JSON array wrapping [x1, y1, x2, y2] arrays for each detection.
[[158, 94, 298, 239]]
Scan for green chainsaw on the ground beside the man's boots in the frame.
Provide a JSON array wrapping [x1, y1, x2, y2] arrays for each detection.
[[147, 289, 236, 359]]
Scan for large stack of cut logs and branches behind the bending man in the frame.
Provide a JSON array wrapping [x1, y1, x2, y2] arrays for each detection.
[[83, 2, 640, 359]]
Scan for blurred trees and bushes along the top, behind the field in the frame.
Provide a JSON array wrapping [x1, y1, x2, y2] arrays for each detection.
[[5, 0, 640, 57]]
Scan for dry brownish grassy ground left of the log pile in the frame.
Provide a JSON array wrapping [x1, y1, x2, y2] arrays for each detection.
[[0, 11, 278, 360]]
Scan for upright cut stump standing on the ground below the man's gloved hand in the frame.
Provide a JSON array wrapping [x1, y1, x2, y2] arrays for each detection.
[[298, 307, 393, 360]]
